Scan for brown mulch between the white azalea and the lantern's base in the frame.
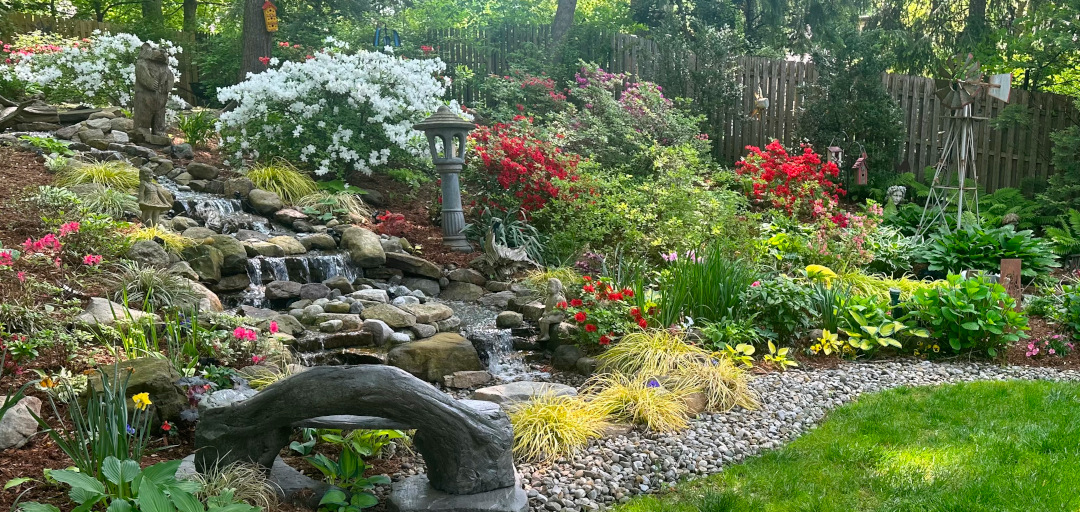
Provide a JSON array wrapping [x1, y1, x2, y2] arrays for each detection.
[[349, 173, 481, 268]]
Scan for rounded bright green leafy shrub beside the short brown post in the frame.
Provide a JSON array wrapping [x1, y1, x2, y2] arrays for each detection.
[[910, 275, 1028, 358]]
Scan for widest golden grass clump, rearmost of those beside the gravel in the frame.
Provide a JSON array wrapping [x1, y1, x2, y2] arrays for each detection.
[[597, 329, 757, 410]]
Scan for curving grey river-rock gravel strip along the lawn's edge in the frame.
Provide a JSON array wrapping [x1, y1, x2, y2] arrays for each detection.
[[517, 361, 1080, 512]]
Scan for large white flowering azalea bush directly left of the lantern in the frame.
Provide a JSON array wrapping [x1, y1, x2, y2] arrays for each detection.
[[217, 50, 460, 176]]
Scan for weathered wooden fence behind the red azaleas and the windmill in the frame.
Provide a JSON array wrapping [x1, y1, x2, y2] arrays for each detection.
[[424, 26, 1080, 191]]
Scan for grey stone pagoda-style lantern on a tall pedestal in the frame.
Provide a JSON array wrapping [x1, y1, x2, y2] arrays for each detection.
[[413, 105, 474, 253]]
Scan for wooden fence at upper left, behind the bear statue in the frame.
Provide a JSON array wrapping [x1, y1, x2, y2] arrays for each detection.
[[5, 12, 199, 105]]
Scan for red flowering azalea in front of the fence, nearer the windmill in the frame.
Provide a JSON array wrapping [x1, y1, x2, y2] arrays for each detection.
[[735, 140, 847, 227]]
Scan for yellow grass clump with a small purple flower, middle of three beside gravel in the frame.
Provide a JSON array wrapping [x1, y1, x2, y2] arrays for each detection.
[[586, 374, 697, 432]]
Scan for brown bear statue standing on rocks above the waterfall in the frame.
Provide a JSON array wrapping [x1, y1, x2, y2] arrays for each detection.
[[132, 43, 176, 146]]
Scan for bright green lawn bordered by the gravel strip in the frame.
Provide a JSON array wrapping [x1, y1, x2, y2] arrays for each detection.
[[616, 382, 1080, 512]]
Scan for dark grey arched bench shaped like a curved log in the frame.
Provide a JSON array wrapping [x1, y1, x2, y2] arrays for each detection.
[[195, 365, 524, 499]]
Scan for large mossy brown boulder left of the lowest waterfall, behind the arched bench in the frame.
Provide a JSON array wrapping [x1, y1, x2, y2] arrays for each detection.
[[387, 333, 484, 382]]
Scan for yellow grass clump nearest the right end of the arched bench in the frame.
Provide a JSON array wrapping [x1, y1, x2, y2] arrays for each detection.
[[510, 394, 608, 460]]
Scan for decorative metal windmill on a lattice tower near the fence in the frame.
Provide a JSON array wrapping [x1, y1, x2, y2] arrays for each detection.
[[918, 53, 1012, 237]]
